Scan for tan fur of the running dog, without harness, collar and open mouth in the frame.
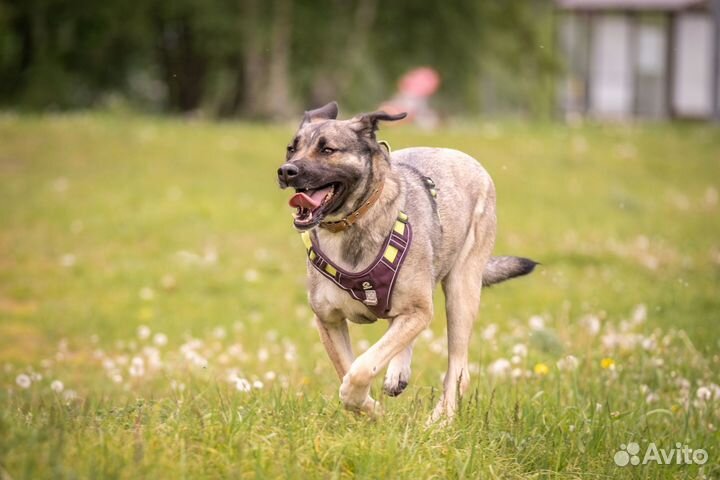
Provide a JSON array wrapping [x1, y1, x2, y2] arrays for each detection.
[[281, 103, 534, 420]]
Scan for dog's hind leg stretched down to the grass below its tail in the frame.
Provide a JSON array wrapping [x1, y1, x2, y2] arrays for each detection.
[[430, 202, 495, 422]]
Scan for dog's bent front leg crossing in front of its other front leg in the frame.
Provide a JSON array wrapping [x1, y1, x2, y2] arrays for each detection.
[[340, 306, 432, 414]]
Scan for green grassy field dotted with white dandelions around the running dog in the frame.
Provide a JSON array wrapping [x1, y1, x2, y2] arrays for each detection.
[[0, 114, 720, 480]]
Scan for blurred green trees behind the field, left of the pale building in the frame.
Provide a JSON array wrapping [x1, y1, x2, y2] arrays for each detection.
[[0, 0, 557, 118]]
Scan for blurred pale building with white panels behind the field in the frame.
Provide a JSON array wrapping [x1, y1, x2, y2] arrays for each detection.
[[557, 0, 720, 120]]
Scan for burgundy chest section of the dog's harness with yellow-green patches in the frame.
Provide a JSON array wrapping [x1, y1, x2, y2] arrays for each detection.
[[302, 212, 412, 318]]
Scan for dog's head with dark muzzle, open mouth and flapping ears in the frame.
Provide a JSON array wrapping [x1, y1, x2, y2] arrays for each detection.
[[278, 102, 407, 230]]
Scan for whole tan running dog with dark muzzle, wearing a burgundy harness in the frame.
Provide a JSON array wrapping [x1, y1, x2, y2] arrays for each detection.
[[277, 102, 536, 421]]
